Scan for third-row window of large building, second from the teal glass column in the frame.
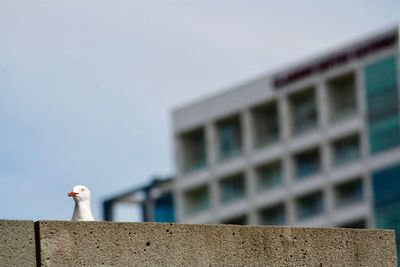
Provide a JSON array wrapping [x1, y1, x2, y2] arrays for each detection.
[[296, 192, 324, 220]]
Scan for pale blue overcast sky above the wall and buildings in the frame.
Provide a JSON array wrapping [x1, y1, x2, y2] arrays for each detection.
[[0, 0, 400, 220]]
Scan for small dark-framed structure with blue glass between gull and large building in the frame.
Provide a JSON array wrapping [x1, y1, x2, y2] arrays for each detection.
[[103, 177, 175, 222]]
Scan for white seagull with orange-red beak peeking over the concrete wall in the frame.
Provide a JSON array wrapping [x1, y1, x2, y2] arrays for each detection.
[[68, 185, 94, 221]]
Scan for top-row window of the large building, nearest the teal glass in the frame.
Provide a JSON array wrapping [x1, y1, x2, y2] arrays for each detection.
[[328, 73, 357, 122]]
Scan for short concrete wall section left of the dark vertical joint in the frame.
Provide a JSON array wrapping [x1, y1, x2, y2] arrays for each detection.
[[0, 220, 36, 267]]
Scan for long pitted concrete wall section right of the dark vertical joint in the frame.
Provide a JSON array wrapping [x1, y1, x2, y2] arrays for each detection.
[[38, 221, 397, 267]]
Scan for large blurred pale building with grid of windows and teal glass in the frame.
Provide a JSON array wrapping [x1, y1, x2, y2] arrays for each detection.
[[173, 28, 400, 248]]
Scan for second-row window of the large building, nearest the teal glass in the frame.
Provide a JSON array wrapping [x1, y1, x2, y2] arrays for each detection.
[[333, 135, 360, 166]]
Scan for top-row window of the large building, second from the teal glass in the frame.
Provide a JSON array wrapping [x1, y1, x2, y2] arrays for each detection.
[[290, 88, 318, 134]]
